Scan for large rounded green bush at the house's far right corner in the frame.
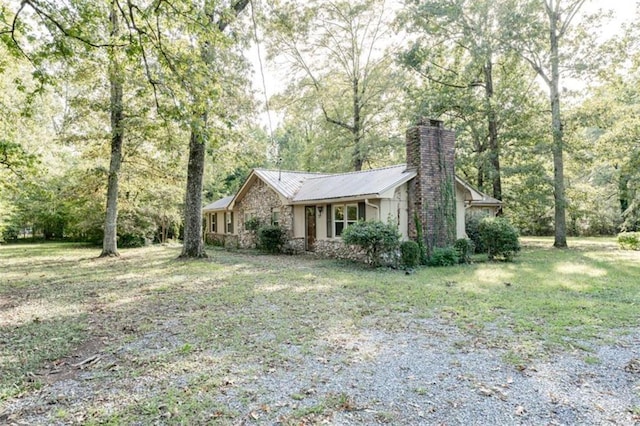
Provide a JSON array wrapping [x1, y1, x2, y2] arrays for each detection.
[[478, 217, 520, 261]]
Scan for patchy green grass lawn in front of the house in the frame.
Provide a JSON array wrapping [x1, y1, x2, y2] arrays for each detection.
[[0, 238, 640, 424]]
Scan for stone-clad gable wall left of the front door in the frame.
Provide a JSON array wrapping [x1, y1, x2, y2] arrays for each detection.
[[235, 179, 293, 248]]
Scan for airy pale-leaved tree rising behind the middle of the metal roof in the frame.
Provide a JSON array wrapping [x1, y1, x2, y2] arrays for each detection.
[[268, 0, 401, 170]]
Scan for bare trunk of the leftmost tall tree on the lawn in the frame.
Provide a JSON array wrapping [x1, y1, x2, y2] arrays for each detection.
[[100, 2, 124, 257]]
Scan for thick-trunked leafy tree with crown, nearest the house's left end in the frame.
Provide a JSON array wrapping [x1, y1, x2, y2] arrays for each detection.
[[128, 0, 249, 258]]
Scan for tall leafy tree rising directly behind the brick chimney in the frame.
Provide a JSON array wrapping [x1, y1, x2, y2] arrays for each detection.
[[401, 0, 520, 200]]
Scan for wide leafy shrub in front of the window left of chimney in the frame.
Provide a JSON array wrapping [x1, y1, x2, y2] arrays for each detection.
[[342, 220, 400, 266]]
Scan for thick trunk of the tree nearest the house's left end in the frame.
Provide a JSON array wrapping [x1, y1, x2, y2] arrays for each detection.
[[180, 120, 207, 258]]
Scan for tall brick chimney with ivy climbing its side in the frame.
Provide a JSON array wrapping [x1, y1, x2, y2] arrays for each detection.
[[407, 120, 456, 256]]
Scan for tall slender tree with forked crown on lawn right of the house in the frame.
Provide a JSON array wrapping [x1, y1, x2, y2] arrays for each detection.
[[503, 0, 586, 248]]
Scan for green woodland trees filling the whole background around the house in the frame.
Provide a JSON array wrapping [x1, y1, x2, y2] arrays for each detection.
[[0, 0, 640, 257]]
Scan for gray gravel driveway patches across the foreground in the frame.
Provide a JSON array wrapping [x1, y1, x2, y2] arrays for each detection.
[[0, 319, 640, 425]]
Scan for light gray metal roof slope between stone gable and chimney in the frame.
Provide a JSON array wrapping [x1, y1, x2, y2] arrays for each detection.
[[292, 164, 416, 202]]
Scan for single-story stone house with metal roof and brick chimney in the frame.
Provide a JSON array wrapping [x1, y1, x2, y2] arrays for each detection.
[[203, 120, 501, 257]]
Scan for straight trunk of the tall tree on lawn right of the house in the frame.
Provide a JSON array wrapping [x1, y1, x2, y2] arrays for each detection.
[[548, 8, 567, 248]]
